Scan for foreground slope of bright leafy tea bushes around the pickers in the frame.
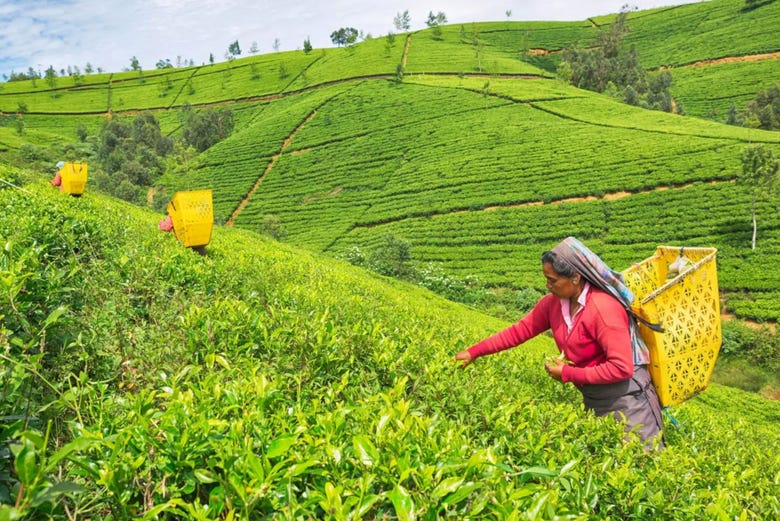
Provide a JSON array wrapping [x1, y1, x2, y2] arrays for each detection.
[[0, 167, 780, 520]]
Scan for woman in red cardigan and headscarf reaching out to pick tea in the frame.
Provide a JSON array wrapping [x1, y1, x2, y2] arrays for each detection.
[[455, 237, 663, 448]]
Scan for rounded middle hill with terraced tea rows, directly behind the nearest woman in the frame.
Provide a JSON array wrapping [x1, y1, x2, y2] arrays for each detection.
[[197, 77, 780, 319]]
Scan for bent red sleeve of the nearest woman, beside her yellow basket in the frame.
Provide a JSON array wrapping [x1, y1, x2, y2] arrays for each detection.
[[561, 294, 634, 385]]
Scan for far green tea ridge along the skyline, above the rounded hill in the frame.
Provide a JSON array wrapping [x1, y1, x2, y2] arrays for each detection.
[[0, 0, 780, 118]]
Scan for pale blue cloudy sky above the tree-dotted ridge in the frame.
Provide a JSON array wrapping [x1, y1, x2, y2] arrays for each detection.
[[0, 0, 698, 81]]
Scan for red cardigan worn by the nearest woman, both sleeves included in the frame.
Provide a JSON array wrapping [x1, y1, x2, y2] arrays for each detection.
[[469, 286, 634, 386]]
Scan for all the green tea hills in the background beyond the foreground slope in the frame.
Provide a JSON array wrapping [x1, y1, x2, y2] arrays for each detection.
[[0, 0, 780, 322]]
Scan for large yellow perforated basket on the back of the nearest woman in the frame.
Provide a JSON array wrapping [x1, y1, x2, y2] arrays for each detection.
[[623, 246, 722, 407]]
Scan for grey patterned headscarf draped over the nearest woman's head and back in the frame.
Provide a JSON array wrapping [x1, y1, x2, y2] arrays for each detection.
[[552, 237, 660, 365]]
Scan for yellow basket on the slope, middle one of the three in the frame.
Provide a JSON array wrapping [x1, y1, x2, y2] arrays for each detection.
[[168, 190, 214, 248]]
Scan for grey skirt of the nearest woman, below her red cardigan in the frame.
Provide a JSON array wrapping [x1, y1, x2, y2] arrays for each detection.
[[579, 366, 663, 448]]
